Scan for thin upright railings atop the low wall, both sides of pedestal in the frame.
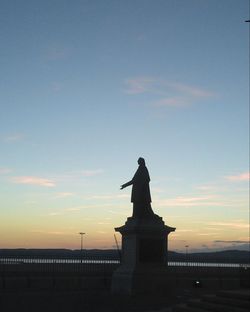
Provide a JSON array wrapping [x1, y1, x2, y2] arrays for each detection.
[[0, 255, 250, 274]]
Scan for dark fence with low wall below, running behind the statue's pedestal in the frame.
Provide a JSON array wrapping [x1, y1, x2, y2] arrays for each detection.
[[0, 255, 250, 293]]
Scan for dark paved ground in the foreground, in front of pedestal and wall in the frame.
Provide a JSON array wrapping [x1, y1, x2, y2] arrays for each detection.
[[0, 289, 249, 312]]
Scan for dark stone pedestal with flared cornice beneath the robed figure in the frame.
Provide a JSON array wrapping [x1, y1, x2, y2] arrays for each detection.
[[112, 215, 175, 295]]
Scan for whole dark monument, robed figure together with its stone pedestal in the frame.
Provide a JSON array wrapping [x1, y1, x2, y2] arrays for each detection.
[[111, 157, 175, 298]]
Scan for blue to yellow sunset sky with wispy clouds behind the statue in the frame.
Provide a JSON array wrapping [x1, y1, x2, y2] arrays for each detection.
[[0, 0, 249, 251]]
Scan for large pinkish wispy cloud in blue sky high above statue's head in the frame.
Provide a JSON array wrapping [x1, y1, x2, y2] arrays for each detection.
[[125, 77, 214, 107]]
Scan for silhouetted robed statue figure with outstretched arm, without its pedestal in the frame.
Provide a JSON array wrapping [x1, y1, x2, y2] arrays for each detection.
[[121, 157, 155, 218]]
